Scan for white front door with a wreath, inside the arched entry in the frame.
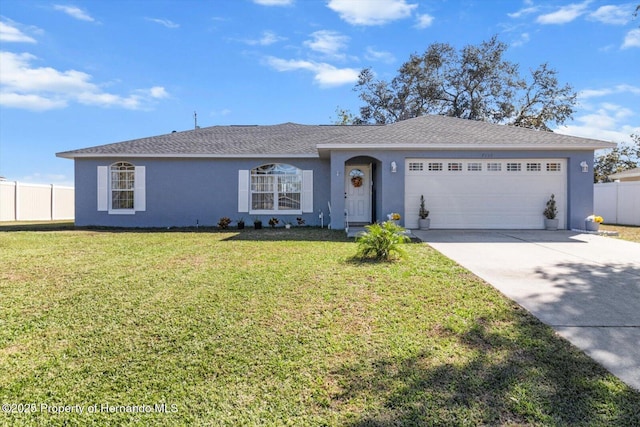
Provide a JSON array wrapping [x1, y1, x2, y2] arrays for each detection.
[[344, 165, 371, 223]]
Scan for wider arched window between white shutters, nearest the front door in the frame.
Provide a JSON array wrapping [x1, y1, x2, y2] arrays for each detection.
[[251, 163, 302, 213]]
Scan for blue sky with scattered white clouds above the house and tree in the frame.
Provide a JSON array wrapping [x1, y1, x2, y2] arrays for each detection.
[[0, 0, 640, 185]]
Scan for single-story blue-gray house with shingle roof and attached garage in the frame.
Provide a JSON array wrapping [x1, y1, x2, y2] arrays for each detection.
[[57, 115, 614, 229]]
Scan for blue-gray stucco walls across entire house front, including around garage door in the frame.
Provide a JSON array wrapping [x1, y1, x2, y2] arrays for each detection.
[[75, 149, 593, 229]]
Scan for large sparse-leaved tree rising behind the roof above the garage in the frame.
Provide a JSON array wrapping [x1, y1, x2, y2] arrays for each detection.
[[342, 36, 576, 130]]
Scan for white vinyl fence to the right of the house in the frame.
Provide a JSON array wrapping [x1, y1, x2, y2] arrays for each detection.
[[593, 181, 640, 225]]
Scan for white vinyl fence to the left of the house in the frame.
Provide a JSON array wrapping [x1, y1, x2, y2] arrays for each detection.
[[0, 181, 75, 221]]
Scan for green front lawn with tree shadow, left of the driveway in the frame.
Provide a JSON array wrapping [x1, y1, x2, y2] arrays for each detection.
[[0, 228, 640, 426]]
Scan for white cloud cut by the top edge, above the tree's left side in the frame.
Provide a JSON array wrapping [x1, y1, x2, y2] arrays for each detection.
[[327, 0, 418, 25]]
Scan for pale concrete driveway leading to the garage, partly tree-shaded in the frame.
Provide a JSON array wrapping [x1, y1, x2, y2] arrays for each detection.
[[413, 230, 640, 390]]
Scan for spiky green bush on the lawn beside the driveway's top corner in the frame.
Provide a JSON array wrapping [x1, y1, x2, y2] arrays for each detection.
[[356, 221, 411, 261]]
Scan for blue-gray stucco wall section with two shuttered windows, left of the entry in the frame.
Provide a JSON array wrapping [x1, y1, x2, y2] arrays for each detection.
[[75, 157, 330, 227]]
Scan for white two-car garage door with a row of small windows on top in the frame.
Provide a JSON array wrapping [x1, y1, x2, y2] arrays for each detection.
[[405, 159, 567, 229]]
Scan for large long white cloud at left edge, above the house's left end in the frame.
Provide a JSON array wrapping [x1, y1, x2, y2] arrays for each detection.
[[0, 52, 169, 111]]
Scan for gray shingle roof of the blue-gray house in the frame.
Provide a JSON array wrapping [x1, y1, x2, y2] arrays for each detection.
[[57, 116, 611, 158]]
